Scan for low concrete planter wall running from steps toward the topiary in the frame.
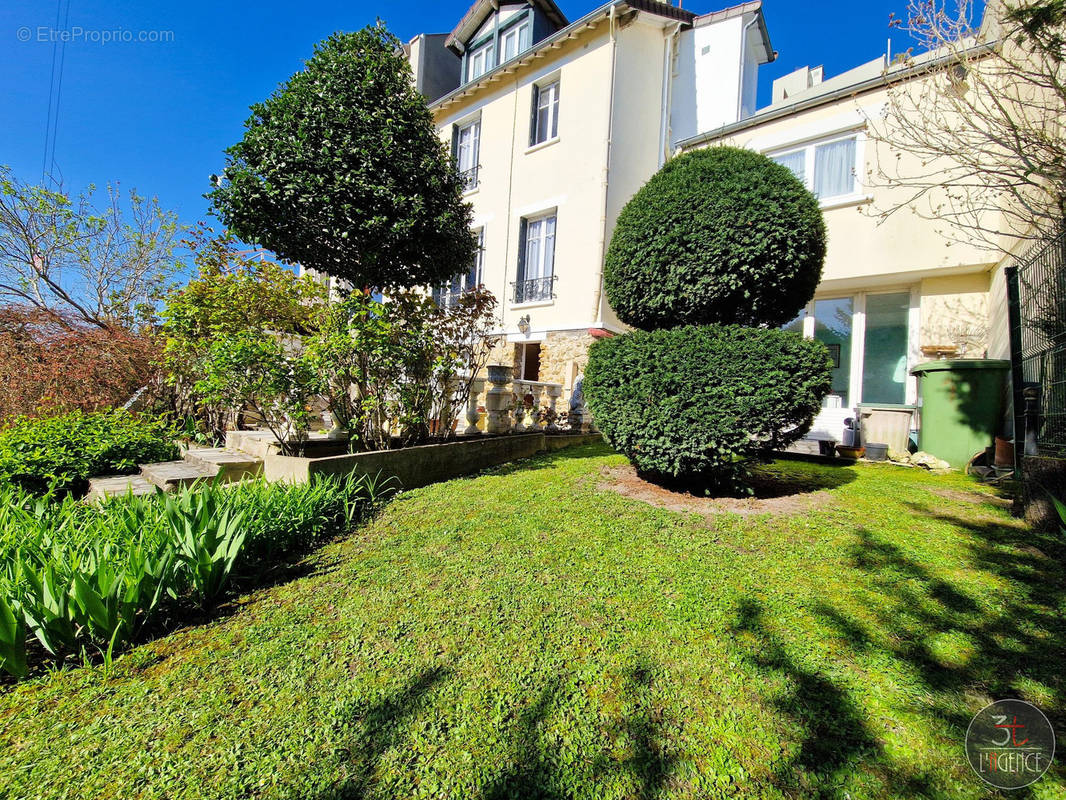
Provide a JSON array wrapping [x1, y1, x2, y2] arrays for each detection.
[[263, 432, 601, 489]]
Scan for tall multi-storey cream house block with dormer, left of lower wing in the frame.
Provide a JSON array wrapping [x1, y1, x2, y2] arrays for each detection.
[[406, 0, 774, 396]]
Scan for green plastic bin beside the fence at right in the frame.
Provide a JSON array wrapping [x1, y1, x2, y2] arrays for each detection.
[[910, 358, 1011, 469]]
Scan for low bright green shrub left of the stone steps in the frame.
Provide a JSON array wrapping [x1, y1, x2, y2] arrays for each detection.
[[0, 411, 178, 494]]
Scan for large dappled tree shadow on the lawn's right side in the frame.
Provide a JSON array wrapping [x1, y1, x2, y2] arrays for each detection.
[[814, 516, 1066, 797]]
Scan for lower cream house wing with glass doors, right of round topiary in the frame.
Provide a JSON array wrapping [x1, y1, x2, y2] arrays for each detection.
[[680, 49, 1006, 448]]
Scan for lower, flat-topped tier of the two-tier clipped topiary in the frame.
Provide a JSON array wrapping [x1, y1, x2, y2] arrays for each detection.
[[584, 325, 830, 485]]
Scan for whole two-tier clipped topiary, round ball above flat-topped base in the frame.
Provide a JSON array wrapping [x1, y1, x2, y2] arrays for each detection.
[[584, 147, 830, 487]]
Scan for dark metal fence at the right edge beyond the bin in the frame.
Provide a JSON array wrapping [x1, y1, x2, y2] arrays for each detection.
[[1006, 229, 1066, 457]]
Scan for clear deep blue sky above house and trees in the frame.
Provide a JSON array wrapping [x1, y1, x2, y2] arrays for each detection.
[[0, 0, 980, 231]]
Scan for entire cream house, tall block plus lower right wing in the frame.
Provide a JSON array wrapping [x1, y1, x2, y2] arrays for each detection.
[[407, 0, 1006, 452]]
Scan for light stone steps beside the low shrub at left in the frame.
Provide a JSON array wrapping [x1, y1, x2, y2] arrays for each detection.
[[85, 441, 265, 501]]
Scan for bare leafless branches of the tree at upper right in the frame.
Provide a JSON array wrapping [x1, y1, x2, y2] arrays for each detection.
[[870, 0, 1066, 253]]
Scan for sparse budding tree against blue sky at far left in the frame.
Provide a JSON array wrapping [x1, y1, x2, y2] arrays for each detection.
[[0, 167, 181, 329]]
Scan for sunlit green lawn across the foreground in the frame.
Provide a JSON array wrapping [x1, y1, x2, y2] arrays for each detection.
[[0, 447, 1066, 800]]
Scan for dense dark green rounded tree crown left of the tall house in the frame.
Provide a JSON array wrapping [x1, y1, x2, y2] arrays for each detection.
[[209, 23, 477, 291]]
